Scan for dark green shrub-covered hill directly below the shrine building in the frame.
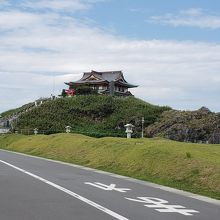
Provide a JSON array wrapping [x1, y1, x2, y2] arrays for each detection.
[[8, 95, 170, 137]]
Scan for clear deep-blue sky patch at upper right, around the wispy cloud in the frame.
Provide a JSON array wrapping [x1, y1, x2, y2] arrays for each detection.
[[83, 0, 220, 42]]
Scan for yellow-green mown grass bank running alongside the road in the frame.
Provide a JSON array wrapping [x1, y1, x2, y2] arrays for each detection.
[[0, 134, 220, 199]]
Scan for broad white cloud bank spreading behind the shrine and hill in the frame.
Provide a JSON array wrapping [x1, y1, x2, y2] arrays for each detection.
[[0, 7, 220, 112]]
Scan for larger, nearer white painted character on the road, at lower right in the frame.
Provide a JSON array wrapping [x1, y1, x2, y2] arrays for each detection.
[[125, 197, 199, 216]]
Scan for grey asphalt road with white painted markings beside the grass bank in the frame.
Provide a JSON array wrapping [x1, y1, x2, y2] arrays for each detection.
[[0, 150, 220, 220]]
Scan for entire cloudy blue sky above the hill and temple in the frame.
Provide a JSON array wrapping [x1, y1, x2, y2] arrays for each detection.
[[0, 0, 220, 112]]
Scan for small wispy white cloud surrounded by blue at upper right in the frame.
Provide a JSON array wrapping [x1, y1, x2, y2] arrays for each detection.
[[149, 8, 220, 29]]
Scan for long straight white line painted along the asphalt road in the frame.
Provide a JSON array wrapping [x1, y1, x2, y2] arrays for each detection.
[[0, 160, 129, 220]]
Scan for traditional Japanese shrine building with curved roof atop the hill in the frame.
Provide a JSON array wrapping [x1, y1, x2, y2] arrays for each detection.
[[65, 70, 137, 96]]
